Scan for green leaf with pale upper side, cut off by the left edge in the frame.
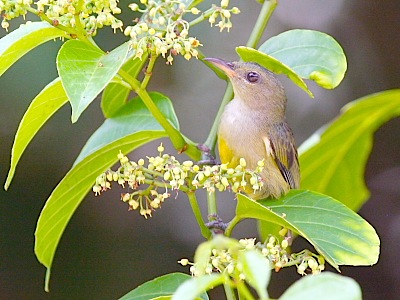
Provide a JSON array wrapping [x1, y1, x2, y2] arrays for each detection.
[[0, 22, 68, 76]]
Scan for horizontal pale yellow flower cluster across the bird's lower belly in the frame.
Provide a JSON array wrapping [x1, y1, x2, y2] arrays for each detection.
[[93, 145, 264, 218]]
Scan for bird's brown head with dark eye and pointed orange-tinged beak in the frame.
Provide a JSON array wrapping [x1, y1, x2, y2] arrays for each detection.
[[205, 58, 286, 118]]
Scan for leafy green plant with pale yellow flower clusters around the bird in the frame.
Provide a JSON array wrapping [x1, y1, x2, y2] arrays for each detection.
[[0, 0, 400, 300]]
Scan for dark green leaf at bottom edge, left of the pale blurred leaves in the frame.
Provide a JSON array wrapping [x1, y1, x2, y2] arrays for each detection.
[[120, 273, 208, 300]]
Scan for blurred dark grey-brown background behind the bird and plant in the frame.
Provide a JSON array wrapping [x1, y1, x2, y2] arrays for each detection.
[[0, 0, 400, 299]]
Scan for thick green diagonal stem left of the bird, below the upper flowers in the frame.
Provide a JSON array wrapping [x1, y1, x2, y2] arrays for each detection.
[[118, 69, 201, 160]]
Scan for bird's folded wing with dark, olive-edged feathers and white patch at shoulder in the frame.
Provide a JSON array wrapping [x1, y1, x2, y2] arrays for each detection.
[[264, 123, 300, 189]]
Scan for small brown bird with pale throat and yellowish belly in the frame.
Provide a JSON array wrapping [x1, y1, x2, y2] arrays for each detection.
[[205, 58, 300, 200]]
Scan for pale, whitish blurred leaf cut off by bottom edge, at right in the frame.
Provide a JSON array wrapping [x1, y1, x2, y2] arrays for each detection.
[[279, 272, 362, 300]]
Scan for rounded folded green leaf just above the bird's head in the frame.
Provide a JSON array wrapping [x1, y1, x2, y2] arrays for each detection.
[[236, 29, 347, 97]]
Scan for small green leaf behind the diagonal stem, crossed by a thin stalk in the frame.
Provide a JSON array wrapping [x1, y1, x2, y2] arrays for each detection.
[[101, 50, 147, 118]]
